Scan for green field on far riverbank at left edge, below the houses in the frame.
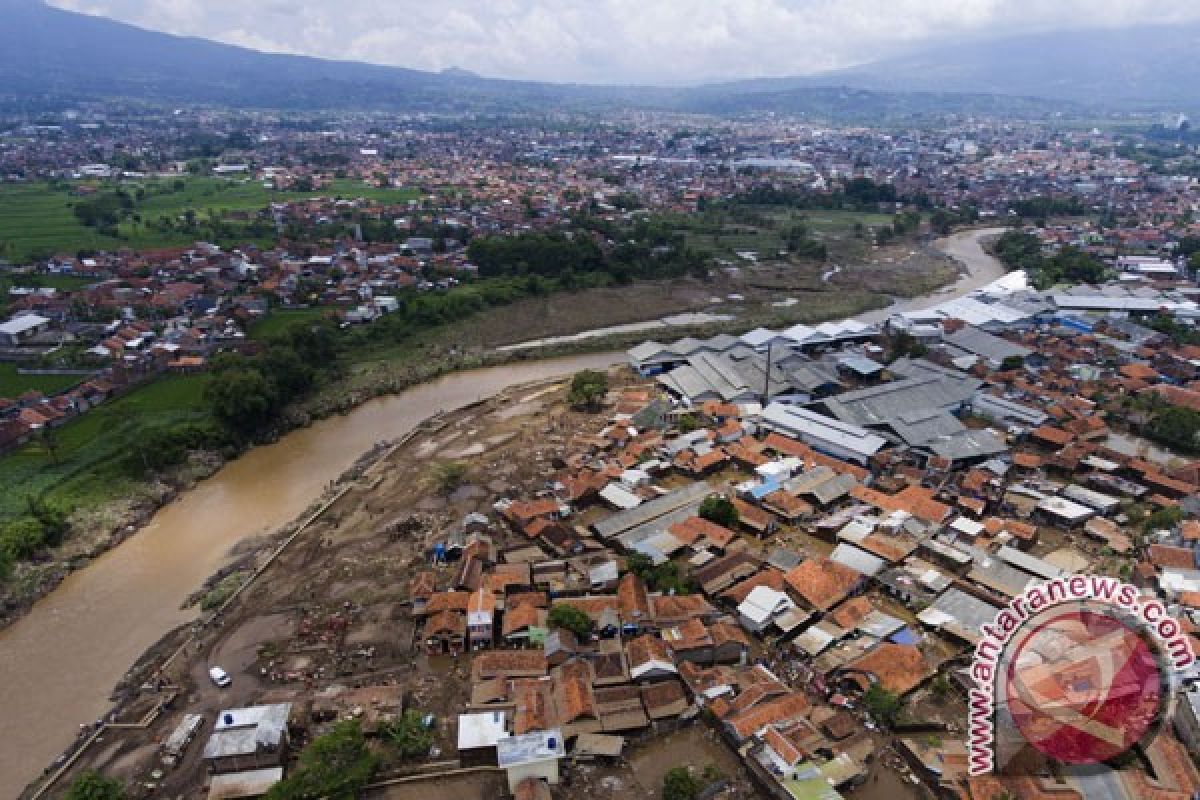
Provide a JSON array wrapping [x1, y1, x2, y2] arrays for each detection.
[[0, 375, 209, 519]]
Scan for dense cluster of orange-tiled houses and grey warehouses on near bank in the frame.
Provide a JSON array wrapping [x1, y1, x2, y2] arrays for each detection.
[[379, 278, 1200, 800]]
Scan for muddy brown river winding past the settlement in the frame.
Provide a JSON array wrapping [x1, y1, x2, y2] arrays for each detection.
[[0, 225, 1003, 798]]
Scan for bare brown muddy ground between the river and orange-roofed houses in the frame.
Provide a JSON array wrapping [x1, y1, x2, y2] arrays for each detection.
[[39, 374, 657, 796]]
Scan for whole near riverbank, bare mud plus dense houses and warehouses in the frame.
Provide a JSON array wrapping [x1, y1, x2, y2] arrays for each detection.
[[25, 247, 1200, 800]]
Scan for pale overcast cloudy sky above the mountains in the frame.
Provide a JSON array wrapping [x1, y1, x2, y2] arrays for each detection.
[[50, 0, 1200, 84]]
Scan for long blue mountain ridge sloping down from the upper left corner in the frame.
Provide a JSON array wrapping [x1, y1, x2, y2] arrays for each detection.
[[0, 0, 1070, 119]]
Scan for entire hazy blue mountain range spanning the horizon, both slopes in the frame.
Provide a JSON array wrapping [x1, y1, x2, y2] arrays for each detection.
[[0, 0, 1200, 118]]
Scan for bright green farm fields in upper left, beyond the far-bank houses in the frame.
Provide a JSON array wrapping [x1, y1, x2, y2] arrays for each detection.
[[0, 176, 419, 263]]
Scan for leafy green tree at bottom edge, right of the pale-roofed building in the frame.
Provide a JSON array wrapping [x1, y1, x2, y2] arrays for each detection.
[[266, 720, 379, 800]]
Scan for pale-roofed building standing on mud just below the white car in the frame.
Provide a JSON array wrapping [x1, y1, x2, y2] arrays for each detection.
[[202, 703, 292, 774]]
